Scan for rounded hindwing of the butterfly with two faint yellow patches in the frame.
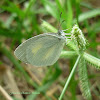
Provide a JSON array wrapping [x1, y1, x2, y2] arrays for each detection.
[[26, 35, 65, 66]]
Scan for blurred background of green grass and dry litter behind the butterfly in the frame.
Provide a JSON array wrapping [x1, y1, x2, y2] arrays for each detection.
[[0, 0, 100, 100]]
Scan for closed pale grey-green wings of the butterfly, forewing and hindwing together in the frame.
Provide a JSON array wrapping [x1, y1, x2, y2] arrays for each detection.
[[14, 33, 65, 66]]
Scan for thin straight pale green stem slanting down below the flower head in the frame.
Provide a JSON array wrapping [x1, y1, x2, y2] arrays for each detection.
[[59, 55, 80, 100]]
